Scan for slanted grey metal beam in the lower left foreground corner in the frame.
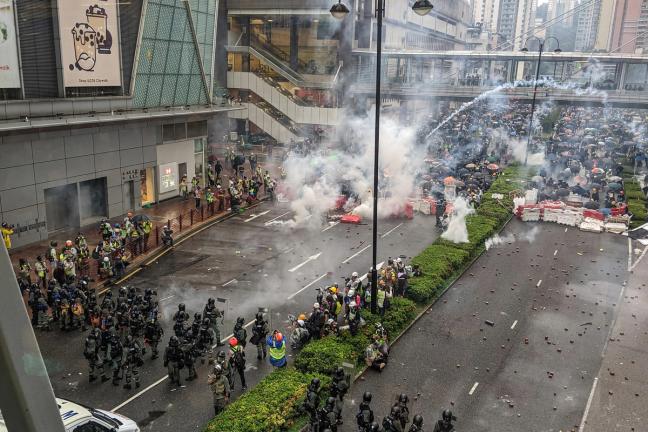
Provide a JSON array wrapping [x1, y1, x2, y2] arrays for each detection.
[[0, 242, 65, 432]]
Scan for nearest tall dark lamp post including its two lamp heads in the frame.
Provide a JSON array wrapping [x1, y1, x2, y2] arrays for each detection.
[[330, 0, 434, 314]]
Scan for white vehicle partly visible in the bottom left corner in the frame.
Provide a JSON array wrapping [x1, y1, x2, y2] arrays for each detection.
[[0, 398, 140, 432]]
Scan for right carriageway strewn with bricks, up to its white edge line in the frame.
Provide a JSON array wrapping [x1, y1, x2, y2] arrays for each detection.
[[345, 220, 628, 432]]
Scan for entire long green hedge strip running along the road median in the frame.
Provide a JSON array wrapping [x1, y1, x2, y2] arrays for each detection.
[[205, 166, 532, 432]]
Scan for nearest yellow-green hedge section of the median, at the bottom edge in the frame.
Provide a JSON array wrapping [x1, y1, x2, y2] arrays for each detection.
[[205, 367, 330, 432]]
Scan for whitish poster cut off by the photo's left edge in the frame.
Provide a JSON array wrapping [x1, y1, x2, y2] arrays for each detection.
[[0, 0, 20, 88]]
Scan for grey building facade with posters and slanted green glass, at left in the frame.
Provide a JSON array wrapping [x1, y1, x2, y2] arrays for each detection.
[[0, 0, 234, 246]]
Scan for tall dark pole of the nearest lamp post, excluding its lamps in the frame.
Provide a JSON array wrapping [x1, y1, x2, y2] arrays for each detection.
[[371, 0, 385, 314]]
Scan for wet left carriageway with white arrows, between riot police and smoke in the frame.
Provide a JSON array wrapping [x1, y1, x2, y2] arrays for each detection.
[[38, 204, 436, 432]]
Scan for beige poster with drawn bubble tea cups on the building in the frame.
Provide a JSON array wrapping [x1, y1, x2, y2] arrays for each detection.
[[58, 0, 121, 87]]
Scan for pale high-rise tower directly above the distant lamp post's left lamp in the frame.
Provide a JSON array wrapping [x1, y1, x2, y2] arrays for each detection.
[[498, 0, 537, 51]]
